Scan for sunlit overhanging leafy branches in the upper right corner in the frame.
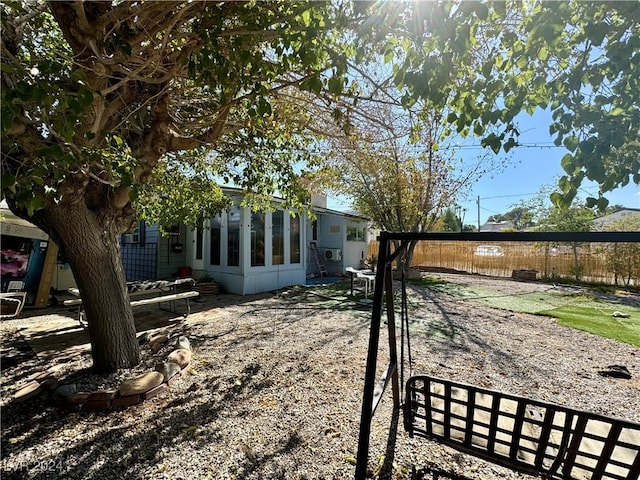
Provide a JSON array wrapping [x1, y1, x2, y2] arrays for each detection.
[[370, 1, 640, 209]]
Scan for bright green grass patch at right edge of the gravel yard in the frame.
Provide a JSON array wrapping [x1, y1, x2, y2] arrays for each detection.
[[539, 304, 640, 347]]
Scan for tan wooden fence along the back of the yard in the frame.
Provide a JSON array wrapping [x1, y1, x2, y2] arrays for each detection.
[[369, 241, 640, 285]]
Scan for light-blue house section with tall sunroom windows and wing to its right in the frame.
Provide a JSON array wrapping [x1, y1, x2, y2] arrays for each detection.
[[178, 189, 370, 295]]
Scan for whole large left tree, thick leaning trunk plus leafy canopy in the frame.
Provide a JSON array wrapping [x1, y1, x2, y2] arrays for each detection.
[[0, 1, 361, 371]]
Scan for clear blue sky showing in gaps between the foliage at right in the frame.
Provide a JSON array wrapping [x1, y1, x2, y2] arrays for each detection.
[[327, 112, 640, 225]]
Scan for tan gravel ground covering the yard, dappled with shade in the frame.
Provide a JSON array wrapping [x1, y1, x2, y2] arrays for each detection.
[[0, 275, 640, 480]]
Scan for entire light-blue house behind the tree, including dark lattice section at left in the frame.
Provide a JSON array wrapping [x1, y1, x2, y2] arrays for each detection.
[[121, 189, 370, 295]]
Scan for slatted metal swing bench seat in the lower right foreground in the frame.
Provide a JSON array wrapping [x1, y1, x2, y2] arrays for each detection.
[[404, 375, 640, 480]]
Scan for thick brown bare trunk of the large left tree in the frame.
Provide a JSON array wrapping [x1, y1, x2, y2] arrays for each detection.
[[38, 202, 140, 373]]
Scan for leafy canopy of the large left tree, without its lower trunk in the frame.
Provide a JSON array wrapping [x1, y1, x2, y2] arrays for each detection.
[[2, 2, 360, 229]]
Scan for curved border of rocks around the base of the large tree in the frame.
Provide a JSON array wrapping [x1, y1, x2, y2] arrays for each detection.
[[13, 328, 193, 412]]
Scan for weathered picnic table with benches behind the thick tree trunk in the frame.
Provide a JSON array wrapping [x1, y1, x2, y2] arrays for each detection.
[[63, 278, 200, 327]]
